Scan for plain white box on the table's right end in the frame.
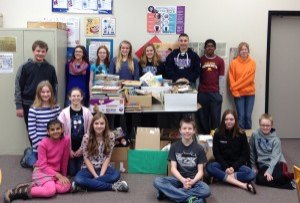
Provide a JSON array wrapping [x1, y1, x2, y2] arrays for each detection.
[[164, 93, 197, 112]]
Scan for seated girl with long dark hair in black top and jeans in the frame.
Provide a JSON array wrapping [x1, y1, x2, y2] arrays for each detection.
[[206, 109, 256, 194]]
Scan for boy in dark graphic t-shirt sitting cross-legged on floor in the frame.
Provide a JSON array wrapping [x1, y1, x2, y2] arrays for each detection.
[[154, 118, 210, 203]]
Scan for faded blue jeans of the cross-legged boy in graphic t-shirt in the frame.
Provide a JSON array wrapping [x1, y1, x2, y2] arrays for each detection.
[[153, 176, 210, 203]]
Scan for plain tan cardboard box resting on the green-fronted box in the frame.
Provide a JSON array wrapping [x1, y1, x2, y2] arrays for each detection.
[[135, 127, 160, 150]]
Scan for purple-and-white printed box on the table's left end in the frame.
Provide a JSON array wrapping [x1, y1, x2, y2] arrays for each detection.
[[90, 96, 125, 114]]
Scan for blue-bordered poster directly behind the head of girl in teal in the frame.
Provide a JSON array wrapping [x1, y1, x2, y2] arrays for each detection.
[[86, 39, 113, 64]]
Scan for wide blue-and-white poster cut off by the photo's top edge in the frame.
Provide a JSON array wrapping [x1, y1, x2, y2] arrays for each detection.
[[52, 0, 113, 14]]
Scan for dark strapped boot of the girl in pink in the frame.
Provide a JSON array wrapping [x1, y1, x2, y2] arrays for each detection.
[[4, 185, 29, 203]]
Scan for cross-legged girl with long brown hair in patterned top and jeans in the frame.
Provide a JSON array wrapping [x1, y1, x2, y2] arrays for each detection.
[[72, 113, 128, 192]]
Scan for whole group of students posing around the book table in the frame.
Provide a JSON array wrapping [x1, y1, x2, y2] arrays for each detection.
[[4, 34, 293, 202]]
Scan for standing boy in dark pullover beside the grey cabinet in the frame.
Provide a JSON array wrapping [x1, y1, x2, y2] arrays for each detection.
[[15, 40, 57, 143]]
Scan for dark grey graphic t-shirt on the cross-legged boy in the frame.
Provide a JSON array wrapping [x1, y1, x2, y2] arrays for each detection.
[[168, 140, 207, 178]]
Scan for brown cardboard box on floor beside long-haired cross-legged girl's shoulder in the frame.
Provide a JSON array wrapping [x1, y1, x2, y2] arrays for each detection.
[[110, 147, 129, 173]]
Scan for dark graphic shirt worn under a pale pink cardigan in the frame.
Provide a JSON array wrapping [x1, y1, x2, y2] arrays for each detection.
[[70, 108, 84, 151]]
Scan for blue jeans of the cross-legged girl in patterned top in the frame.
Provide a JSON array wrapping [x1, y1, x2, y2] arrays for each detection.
[[74, 166, 120, 191]]
